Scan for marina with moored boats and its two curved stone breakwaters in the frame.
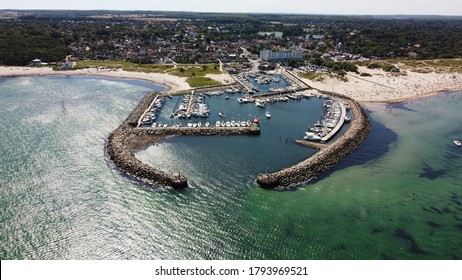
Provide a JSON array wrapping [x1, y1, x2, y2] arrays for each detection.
[[107, 69, 370, 189]]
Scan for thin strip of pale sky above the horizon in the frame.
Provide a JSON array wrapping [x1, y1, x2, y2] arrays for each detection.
[[0, 0, 462, 16]]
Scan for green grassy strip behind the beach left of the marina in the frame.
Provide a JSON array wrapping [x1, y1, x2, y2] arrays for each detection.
[[74, 60, 221, 87]]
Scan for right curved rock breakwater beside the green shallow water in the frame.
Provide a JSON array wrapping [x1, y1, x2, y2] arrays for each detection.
[[257, 99, 371, 189]]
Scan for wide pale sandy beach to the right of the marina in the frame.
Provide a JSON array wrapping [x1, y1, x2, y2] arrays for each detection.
[[303, 67, 462, 102]]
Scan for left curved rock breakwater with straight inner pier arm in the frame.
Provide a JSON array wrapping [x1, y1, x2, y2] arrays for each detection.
[[106, 93, 260, 189]]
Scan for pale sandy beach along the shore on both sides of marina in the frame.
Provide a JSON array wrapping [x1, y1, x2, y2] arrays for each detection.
[[0, 63, 462, 103]]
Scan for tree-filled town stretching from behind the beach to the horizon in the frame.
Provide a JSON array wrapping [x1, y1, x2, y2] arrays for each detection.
[[0, 11, 462, 78]]
